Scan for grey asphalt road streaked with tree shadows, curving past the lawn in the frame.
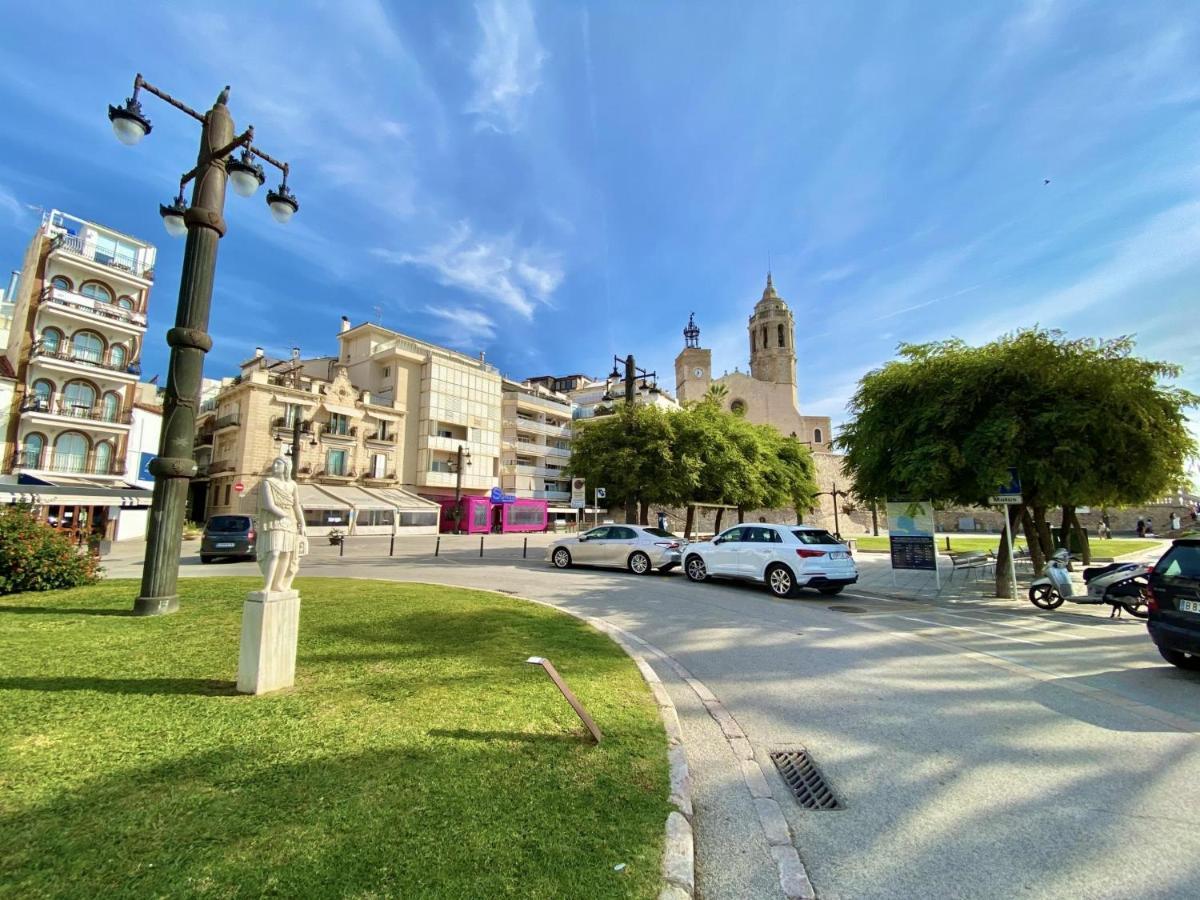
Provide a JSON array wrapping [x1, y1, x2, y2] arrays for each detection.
[[109, 536, 1200, 900]]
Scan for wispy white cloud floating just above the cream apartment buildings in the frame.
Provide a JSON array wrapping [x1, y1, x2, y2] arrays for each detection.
[[372, 222, 563, 319]]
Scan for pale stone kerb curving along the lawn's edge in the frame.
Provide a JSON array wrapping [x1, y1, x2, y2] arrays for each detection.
[[396, 576, 696, 898]]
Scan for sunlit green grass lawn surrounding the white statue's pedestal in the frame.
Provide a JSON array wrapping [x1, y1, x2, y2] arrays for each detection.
[[0, 578, 668, 898]]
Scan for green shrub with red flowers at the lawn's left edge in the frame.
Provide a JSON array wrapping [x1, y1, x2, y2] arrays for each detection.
[[0, 506, 100, 595]]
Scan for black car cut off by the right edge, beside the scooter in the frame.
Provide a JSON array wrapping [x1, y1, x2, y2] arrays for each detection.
[[1146, 538, 1200, 672]]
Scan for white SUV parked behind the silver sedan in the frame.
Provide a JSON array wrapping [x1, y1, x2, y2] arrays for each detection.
[[683, 524, 858, 596]]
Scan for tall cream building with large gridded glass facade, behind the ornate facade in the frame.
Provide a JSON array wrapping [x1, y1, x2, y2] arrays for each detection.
[[337, 318, 500, 498]]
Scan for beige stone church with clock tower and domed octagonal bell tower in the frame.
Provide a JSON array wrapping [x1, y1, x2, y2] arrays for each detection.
[[676, 274, 871, 536]]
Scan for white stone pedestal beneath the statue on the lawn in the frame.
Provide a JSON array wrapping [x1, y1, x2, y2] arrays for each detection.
[[238, 590, 300, 694]]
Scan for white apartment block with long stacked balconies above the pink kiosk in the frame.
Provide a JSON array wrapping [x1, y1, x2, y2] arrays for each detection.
[[500, 378, 574, 512]]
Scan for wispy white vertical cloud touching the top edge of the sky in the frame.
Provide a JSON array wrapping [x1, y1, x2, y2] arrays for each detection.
[[466, 0, 546, 132]]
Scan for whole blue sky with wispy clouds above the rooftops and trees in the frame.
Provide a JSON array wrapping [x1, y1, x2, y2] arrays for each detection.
[[0, 0, 1200, 446]]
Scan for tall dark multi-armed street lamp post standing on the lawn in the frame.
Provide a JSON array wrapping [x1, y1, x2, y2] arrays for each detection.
[[108, 74, 300, 616]]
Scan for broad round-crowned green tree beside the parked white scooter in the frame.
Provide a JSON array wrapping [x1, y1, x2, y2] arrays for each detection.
[[836, 328, 1198, 596]]
